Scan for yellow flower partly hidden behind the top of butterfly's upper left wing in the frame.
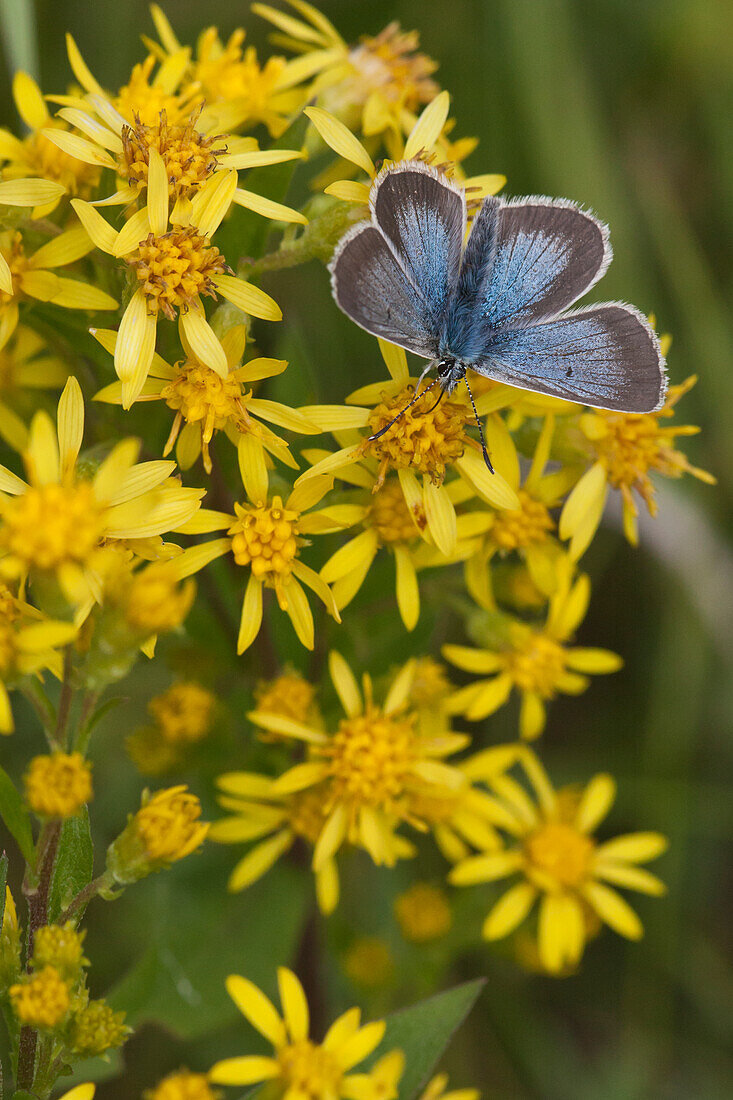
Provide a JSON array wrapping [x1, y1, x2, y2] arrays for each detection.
[[305, 91, 506, 209]]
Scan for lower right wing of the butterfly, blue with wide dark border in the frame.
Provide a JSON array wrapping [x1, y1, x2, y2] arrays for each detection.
[[471, 301, 667, 413]]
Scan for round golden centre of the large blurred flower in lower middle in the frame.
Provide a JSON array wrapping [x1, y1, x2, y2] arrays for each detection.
[[314, 706, 417, 813]]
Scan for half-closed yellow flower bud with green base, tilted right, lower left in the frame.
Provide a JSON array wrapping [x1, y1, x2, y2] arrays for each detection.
[[107, 784, 209, 884]]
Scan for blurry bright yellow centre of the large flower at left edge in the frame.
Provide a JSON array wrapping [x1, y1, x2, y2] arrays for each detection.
[[0, 482, 105, 570]]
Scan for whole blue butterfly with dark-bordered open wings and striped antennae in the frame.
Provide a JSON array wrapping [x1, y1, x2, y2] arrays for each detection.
[[329, 161, 667, 470]]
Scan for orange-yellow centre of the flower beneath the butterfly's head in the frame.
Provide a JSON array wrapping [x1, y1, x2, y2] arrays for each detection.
[[364, 386, 467, 484]]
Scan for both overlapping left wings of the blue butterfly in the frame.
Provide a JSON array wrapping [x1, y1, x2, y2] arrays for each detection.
[[330, 162, 466, 359]]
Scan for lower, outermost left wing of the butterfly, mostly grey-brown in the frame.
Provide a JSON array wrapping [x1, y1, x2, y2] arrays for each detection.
[[329, 222, 437, 359]]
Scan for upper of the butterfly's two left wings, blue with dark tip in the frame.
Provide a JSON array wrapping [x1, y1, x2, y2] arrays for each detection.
[[370, 161, 466, 327]]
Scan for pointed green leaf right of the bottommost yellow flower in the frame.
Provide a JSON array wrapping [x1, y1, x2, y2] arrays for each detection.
[[370, 978, 485, 1100]]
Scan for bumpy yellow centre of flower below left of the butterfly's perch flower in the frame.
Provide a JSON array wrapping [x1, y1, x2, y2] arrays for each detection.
[[229, 496, 299, 587]]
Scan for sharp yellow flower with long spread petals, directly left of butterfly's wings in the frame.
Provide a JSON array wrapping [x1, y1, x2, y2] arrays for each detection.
[[72, 156, 283, 408]]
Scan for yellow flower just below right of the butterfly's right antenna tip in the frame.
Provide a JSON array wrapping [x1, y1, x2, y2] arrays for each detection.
[[466, 413, 573, 609]]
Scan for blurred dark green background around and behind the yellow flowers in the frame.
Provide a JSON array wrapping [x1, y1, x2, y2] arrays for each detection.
[[0, 0, 733, 1100]]
